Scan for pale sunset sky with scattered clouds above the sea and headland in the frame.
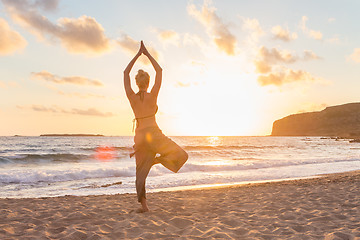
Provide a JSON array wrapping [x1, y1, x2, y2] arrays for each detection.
[[0, 0, 360, 136]]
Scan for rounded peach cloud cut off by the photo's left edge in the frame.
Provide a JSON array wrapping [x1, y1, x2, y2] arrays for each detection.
[[0, 18, 27, 55]]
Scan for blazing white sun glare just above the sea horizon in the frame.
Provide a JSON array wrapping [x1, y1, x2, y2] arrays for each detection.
[[160, 69, 261, 136]]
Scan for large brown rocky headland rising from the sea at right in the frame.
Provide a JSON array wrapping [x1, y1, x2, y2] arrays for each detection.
[[271, 103, 360, 138]]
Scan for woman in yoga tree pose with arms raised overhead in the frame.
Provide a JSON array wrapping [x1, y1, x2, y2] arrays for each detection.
[[124, 41, 188, 212]]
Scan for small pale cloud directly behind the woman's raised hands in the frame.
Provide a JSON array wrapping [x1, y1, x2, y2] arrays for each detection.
[[117, 34, 159, 64]]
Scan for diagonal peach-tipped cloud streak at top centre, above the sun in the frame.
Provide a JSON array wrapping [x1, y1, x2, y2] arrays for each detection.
[[187, 1, 236, 55]]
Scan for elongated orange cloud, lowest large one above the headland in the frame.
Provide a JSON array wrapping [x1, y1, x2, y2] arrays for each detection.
[[257, 68, 319, 86]]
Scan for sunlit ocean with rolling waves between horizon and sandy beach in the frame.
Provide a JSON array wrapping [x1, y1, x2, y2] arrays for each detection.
[[0, 136, 360, 198]]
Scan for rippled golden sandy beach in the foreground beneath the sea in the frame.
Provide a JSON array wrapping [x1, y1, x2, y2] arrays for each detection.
[[0, 171, 360, 239]]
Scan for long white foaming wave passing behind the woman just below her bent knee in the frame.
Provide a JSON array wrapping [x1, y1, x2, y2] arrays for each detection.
[[0, 158, 359, 184]]
